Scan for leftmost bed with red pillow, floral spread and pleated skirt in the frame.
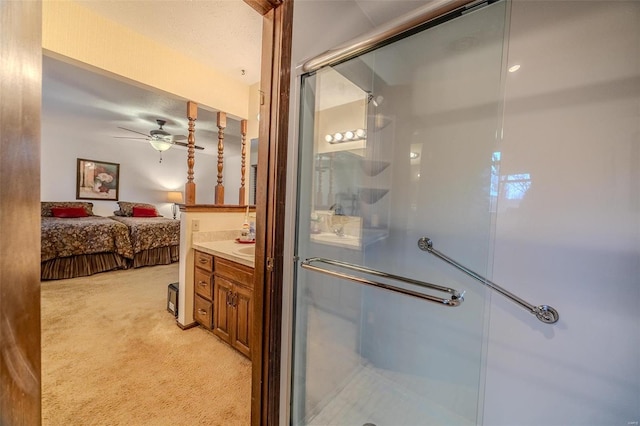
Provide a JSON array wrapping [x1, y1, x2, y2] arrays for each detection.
[[40, 201, 133, 280]]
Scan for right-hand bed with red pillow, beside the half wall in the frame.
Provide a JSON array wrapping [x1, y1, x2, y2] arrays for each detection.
[[111, 201, 180, 268]]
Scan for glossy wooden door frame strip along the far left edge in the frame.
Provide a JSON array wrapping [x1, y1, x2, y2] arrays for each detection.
[[0, 1, 42, 425]]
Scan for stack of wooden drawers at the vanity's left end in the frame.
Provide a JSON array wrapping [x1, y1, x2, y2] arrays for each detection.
[[193, 250, 214, 330]]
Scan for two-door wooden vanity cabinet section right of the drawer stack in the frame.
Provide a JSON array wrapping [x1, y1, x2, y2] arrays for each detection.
[[213, 257, 253, 357]]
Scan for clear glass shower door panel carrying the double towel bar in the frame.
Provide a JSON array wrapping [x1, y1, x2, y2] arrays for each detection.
[[291, 2, 506, 425]]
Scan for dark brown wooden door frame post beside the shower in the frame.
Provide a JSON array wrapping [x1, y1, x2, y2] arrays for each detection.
[[244, 0, 293, 426]]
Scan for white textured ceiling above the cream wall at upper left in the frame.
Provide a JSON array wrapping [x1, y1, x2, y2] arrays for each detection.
[[78, 0, 262, 85]]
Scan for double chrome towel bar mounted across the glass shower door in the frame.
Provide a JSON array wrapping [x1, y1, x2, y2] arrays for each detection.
[[300, 257, 464, 307]]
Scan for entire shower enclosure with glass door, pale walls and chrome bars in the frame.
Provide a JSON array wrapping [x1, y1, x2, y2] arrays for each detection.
[[290, 0, 640, 426]]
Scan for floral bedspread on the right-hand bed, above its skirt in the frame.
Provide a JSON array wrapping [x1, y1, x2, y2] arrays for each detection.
[[112, 216, 180, 254]]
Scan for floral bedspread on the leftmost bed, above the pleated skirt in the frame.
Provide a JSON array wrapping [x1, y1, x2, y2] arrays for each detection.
[[41, 216, 133, 262]]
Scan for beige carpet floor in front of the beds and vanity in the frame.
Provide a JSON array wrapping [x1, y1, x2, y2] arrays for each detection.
[[42, 264, 251, 425]]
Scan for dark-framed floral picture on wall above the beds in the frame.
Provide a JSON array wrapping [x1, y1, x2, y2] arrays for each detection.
[[76, 158, 120, 201]]
